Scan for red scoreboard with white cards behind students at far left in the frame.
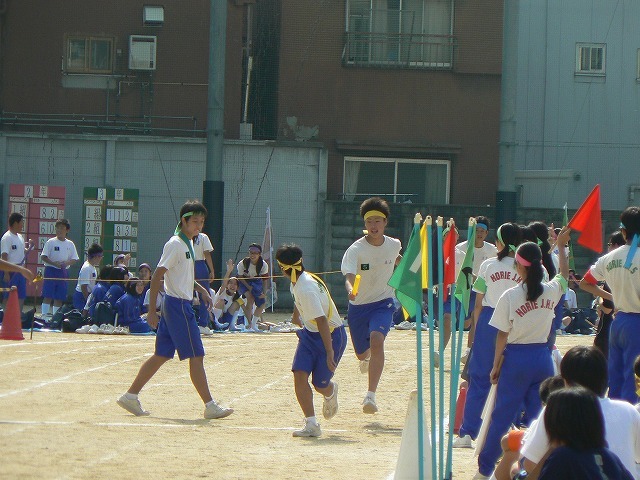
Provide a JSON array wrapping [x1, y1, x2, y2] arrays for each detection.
[[7, 184, 66, 296]]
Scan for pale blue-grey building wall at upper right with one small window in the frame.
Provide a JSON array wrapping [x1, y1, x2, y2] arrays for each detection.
[[516, 0, 640, 210]]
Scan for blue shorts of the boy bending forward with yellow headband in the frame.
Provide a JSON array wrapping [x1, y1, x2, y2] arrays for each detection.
[[291, 327, 347, 388]]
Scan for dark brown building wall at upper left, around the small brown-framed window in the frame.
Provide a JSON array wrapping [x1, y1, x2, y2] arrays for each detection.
[[0, 0, 246, 138]]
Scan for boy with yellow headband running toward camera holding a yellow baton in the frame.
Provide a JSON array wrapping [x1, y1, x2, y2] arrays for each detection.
[[341, 197, 402, 414]]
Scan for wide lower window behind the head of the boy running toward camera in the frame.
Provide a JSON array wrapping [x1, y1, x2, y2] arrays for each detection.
[[343, 157, 450, 204]]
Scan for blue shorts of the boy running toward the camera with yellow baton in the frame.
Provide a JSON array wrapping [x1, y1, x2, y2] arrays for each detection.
[[347, 298, 395, 355]]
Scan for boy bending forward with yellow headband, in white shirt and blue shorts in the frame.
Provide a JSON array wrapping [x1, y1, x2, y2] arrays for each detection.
[[276, 245, 347, 437]]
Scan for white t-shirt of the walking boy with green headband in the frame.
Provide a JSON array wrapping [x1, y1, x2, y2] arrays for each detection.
[[158, 235, 195, 300]]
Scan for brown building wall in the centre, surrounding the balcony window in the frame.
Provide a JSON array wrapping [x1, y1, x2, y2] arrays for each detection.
[[277, 0, 502, 204]]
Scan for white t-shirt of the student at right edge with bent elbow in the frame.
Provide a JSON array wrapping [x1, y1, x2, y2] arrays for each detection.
[[589, 245, 640, 313]]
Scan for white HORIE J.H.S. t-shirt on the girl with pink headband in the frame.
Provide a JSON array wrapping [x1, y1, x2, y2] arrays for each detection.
[[489, 275, 567, 344]]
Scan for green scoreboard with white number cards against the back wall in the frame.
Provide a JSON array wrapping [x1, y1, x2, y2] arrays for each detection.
[[82, 187, 140, 267]]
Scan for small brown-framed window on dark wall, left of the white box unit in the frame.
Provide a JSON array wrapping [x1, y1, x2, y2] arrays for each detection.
[[66, 36, 114, 73]]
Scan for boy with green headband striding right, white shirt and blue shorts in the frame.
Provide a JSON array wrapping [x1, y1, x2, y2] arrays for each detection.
[[118, 201, 233, 418]]
